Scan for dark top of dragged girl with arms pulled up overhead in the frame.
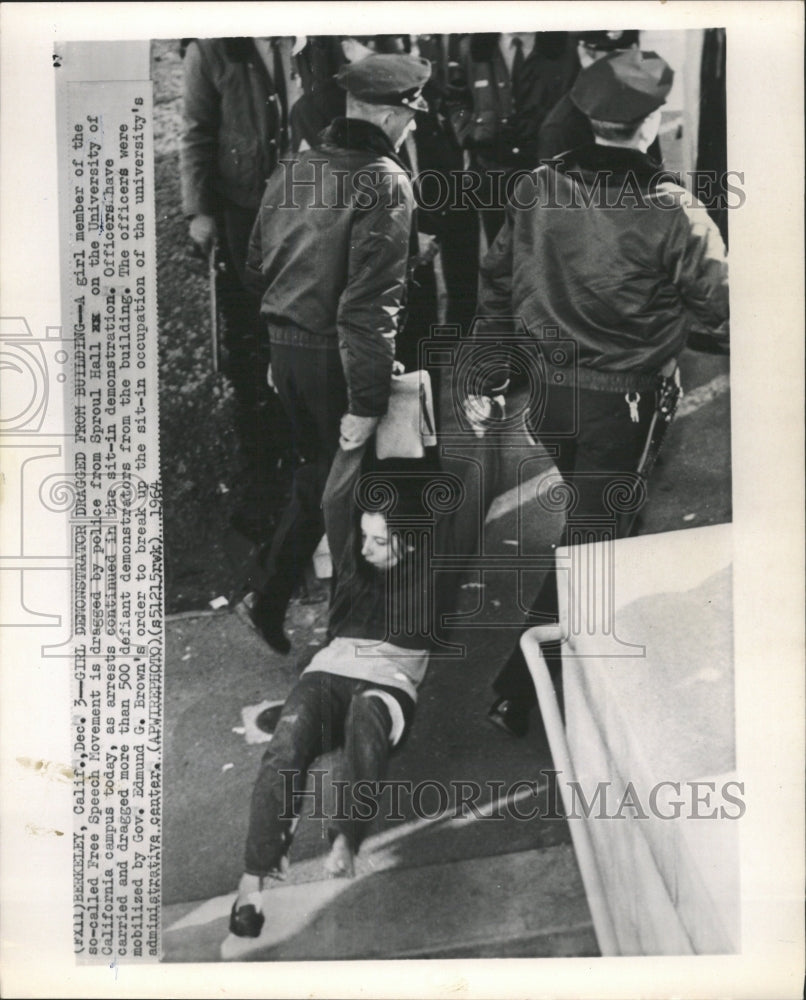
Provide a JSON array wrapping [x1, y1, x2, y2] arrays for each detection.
[[322, 442, 516, 651]]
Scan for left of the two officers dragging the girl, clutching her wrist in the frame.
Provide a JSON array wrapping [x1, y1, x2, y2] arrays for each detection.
[[245, 54, 430, 653]]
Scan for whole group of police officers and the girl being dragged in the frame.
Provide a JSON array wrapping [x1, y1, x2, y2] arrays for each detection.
[[182, 31, 728, 936]]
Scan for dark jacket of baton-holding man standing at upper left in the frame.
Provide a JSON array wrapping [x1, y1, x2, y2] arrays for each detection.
[[180, 38, 295, 215]]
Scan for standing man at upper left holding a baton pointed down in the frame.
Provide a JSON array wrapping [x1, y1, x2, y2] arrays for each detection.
[[180, 37, 301, 542]]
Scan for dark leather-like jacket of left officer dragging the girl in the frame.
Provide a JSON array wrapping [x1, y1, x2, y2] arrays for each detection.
[[247, 118, 414, 417]]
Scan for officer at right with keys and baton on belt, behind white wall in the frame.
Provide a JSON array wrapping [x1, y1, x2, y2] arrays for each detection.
[[479, 50, 728, 735]]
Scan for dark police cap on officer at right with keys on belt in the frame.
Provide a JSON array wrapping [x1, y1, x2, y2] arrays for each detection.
[[570, 49, 674, 124]]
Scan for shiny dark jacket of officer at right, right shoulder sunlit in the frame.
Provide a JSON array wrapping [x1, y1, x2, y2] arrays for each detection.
[[478, 145, 728, 391]]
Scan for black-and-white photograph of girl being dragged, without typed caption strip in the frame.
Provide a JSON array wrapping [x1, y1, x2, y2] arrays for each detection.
[[151, 25, 744, 961]]
